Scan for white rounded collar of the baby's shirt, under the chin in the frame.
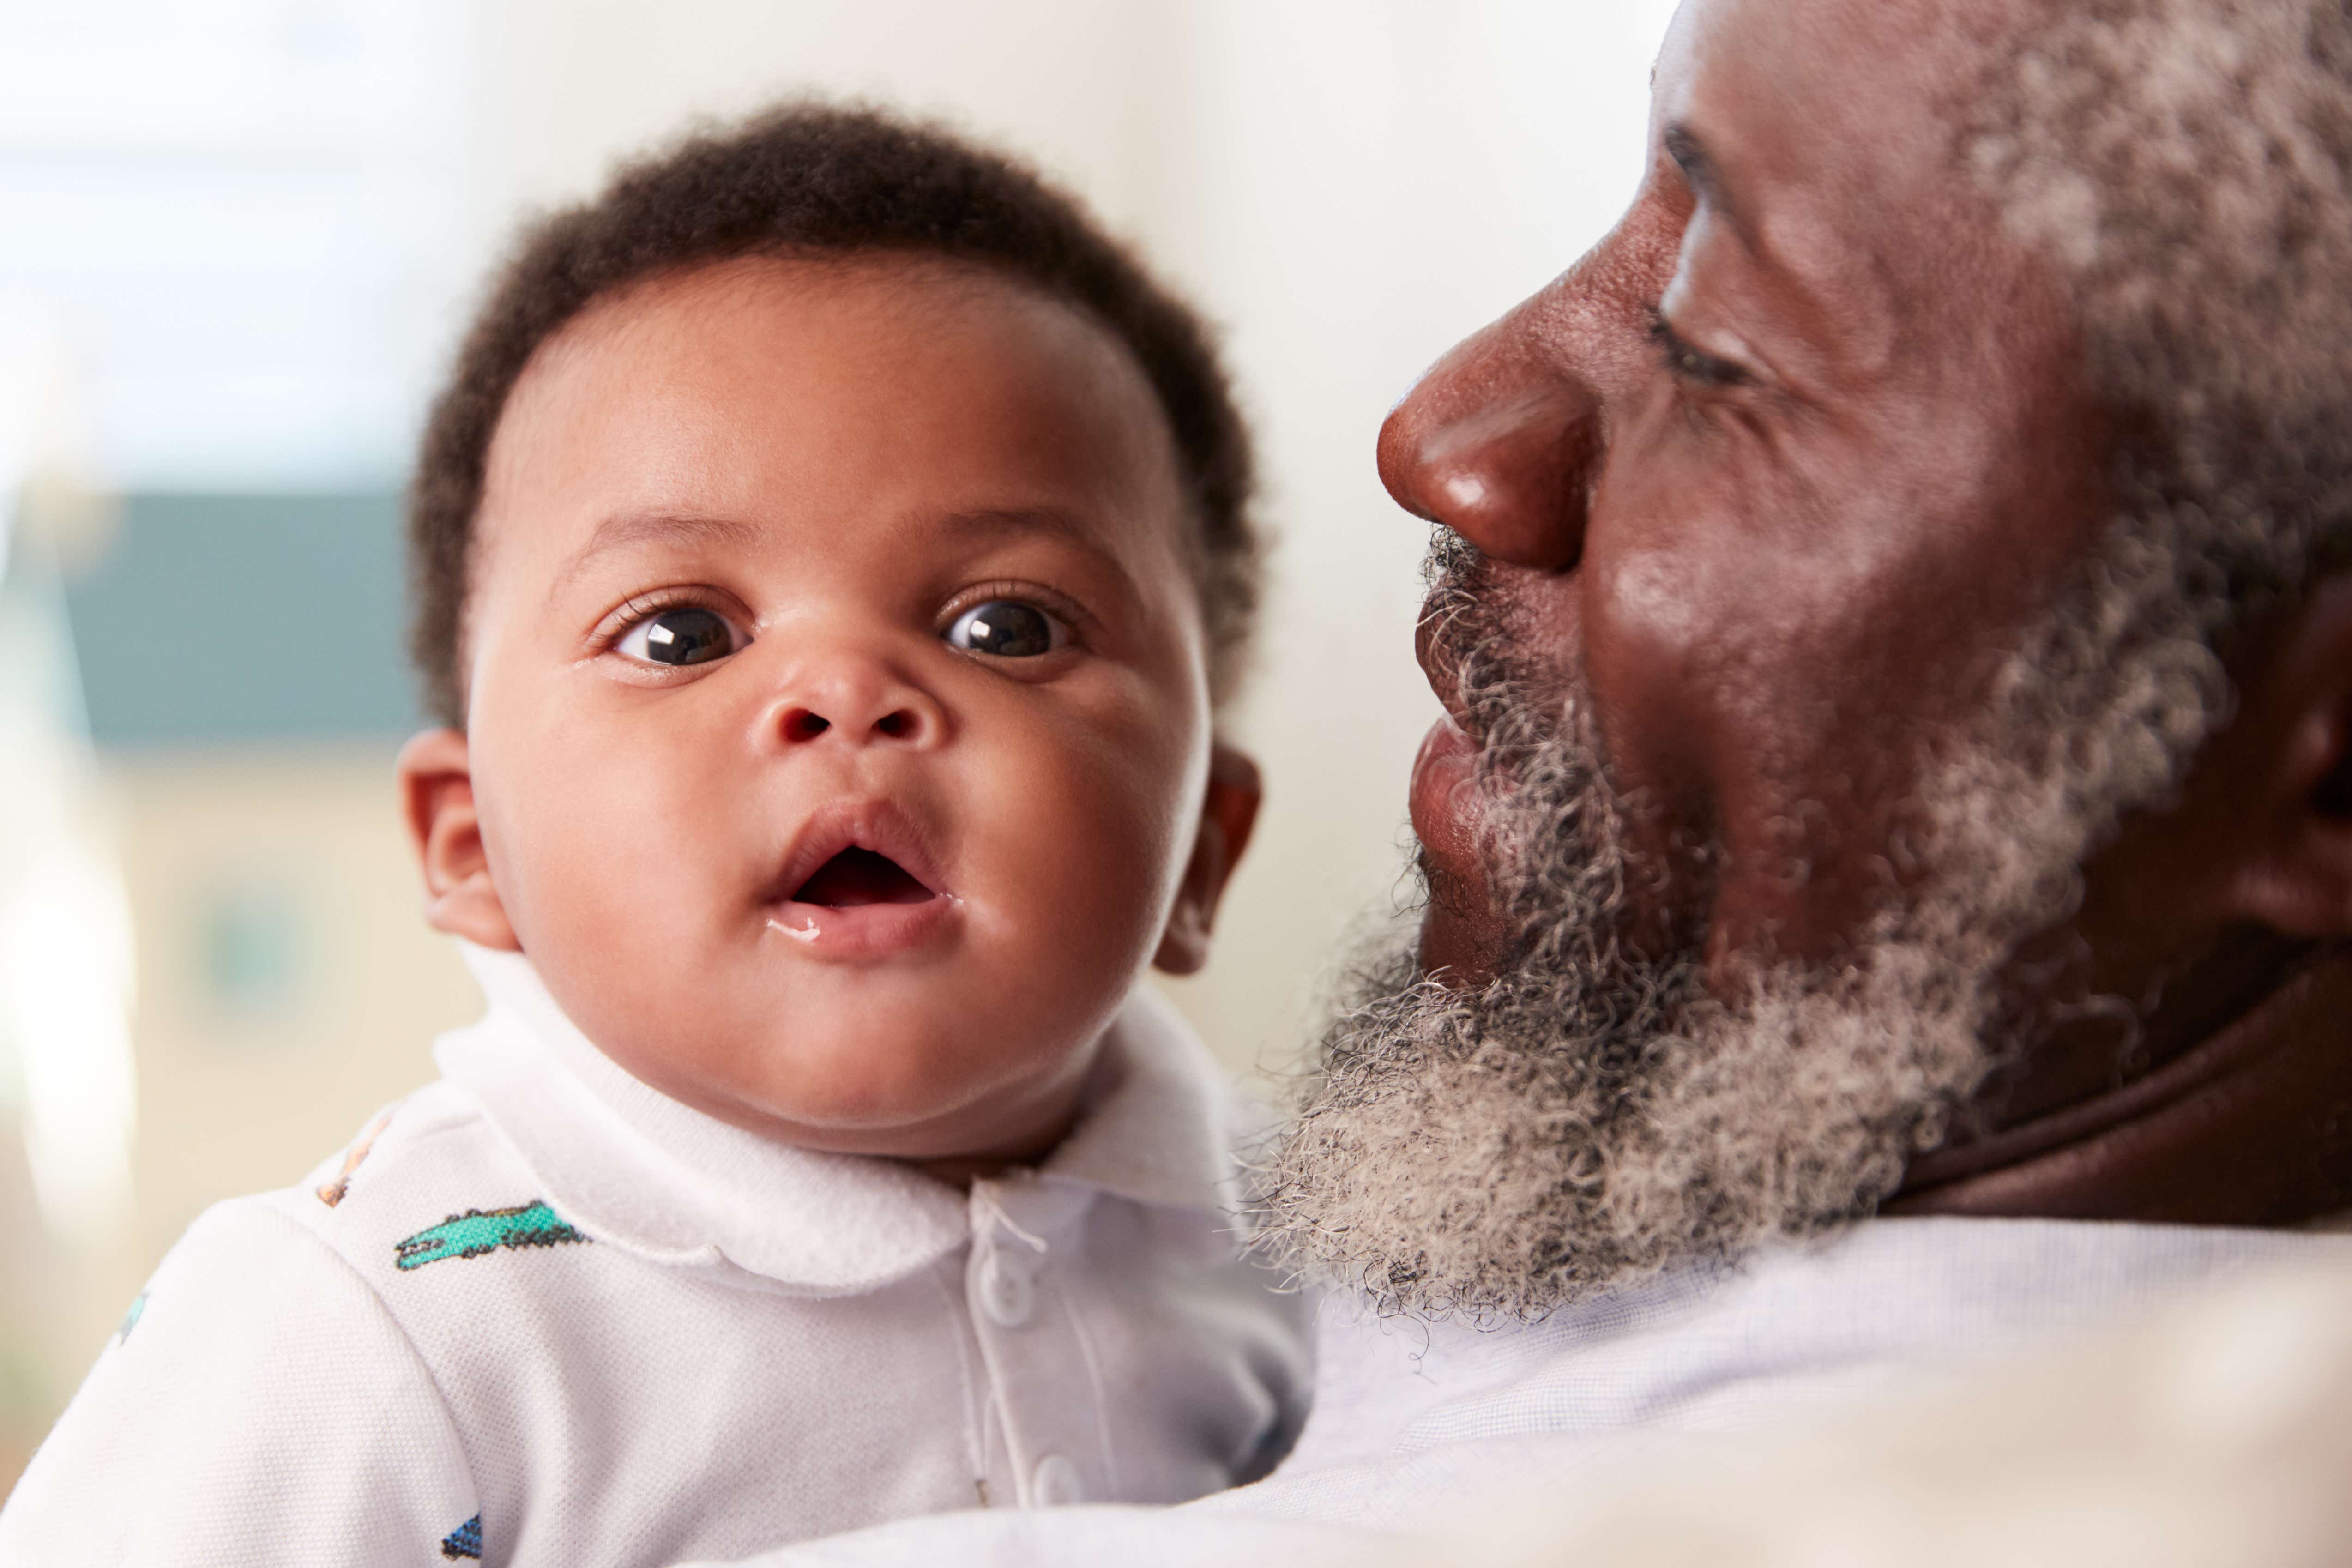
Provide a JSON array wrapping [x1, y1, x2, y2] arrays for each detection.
[[433, 943, 1237, 1295]]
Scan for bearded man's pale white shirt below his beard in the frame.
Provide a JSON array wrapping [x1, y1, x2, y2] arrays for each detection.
[[701, 1218, 2352, 1568]]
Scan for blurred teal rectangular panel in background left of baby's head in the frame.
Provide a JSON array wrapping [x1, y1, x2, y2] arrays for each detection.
[[66, 494, 419, 750]]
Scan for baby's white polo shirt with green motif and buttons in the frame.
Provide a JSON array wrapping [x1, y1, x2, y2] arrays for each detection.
[[0, 950, 1310, 1568]]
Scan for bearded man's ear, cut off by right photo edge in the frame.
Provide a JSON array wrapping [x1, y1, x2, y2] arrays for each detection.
[[2218, 573, 2352, 938]]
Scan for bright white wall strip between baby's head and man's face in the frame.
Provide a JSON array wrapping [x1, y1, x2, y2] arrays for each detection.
[[1146, 0, 1670, 1065]]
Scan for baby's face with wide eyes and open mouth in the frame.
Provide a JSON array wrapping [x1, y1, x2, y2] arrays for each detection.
[[440, 259, 1209, 1157]]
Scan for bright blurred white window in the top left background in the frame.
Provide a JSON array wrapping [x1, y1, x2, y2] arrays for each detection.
[[0, 0, 473, 489]]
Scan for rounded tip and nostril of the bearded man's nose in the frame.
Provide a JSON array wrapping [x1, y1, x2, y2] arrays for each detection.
[[1381, 313, 1602, 571]]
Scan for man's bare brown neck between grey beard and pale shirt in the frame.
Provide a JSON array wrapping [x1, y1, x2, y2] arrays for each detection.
[[1882, 954, 2352, 1225]]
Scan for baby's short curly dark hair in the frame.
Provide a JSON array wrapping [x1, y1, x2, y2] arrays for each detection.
[[409, 101, 1260, 726]]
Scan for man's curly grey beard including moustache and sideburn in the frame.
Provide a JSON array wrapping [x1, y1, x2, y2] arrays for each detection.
[[1268, 538, 2225, 1319]]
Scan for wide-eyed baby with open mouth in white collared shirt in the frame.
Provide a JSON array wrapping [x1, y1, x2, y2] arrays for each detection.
[[0, 108, 1305, 1568]]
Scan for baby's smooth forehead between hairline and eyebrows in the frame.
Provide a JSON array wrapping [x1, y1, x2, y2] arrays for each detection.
[[477, 252, 1193, 583]]
